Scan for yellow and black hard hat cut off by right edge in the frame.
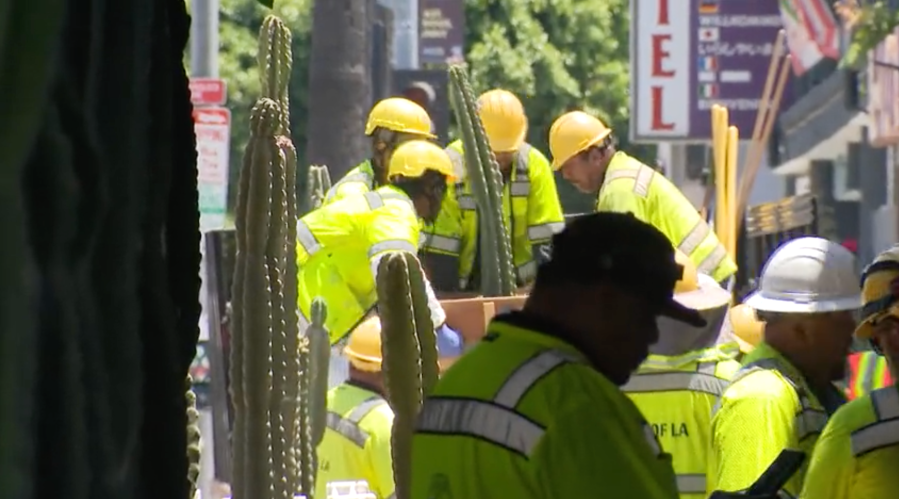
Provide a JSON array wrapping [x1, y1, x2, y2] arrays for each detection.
[[855, 246, 899, 340]]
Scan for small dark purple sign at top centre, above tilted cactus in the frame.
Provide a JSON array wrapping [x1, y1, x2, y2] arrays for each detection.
[[418, 0, 465, 64]]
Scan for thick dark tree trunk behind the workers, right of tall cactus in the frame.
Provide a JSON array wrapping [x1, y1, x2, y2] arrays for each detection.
[[306, 0, 371, 181]]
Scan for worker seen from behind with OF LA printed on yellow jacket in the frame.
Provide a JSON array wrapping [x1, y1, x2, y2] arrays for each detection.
[[621, 251, 740, 499]]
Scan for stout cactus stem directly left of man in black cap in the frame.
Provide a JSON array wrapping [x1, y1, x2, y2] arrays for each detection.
[[377, 252, 438, 499]]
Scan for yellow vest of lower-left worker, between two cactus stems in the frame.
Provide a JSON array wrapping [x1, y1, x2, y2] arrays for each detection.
[[315, 383, 394, 499]]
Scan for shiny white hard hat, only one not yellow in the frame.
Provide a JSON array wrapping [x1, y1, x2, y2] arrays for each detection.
[[745, 237, 861, 313]]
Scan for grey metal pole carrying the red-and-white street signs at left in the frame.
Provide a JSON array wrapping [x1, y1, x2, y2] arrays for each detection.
[[190, 0, 219, 499]]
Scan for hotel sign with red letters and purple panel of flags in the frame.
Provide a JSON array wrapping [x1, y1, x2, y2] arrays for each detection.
[[630, 0, 790, 142]]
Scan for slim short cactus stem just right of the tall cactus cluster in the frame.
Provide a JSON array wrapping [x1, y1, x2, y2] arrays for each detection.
[[297, 298, 331, 499]]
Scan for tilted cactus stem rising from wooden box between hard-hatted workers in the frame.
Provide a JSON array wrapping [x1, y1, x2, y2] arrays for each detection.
[[449, 65, 516, 296]]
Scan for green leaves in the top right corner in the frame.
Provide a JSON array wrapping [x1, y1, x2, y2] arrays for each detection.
[[836, 0, 899, 68]]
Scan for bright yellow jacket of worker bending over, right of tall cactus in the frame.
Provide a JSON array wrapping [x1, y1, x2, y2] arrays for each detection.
[[297, 186, 419, 344]]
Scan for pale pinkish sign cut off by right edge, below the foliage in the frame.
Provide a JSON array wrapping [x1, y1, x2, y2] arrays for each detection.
[[867, 28, 899, 147]]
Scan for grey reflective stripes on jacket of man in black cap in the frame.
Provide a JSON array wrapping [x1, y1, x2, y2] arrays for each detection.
[[416, 350, 661, 458]]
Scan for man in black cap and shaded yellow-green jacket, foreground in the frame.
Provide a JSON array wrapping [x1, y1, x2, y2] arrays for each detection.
[[410, 213, 705, 499]]
